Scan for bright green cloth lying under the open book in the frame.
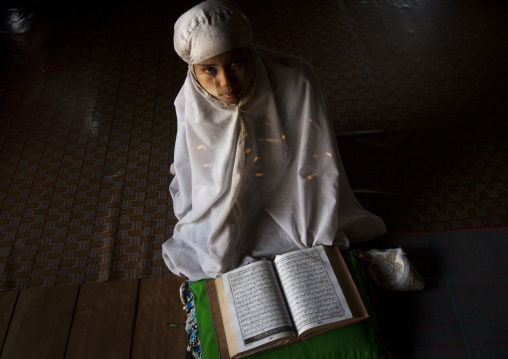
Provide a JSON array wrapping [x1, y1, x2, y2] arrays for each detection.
[[190, 251, 387, 359]]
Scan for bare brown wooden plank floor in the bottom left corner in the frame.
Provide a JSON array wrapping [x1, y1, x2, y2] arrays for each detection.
[[0, 276, 188, 359]]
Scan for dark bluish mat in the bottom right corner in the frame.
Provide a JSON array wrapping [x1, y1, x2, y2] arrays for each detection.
[[370, 227, 508, 359]]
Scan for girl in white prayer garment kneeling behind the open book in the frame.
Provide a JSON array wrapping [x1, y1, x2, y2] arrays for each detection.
[[163, 1, 386, 280]]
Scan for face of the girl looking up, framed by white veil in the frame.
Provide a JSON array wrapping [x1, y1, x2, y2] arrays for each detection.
[[194, 48, 252, 104]]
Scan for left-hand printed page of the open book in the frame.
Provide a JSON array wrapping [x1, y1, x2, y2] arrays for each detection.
[[222, 260, 295, 352]]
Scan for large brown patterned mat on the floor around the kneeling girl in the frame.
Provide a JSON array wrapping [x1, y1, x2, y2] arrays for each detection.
[[0, 0, 508, 290]]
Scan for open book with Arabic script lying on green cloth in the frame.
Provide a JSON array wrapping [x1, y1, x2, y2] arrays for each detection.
[[207, 246, 368, 359]]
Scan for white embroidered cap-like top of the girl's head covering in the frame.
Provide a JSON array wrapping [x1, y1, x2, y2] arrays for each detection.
[[173, 0, 252, 64]]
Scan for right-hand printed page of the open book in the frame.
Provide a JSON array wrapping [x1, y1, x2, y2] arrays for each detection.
[[274, 246, 353, 334]]
